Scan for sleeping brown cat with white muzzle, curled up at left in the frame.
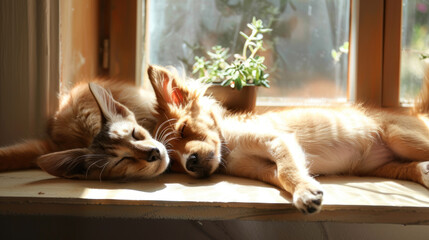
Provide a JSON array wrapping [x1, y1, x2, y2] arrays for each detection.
[[0, 80, 169, 180]]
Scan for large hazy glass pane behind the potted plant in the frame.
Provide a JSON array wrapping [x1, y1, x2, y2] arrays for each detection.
[[149, 0, 350, 101]]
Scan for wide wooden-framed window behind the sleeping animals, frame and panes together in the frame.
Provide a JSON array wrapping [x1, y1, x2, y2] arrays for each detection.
[[56, 0, 427, 107]]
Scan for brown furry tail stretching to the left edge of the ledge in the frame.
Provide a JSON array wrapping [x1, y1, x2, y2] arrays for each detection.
[[0, 139, 53, 172]]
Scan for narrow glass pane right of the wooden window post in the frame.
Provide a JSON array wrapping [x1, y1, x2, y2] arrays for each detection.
[[400, 0, 429, 104]]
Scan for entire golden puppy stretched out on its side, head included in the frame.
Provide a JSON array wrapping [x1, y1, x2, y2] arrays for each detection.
[[148, 67, 429, 213]]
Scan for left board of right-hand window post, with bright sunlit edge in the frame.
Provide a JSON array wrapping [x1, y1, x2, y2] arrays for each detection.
[[348, 0, 384, 106]]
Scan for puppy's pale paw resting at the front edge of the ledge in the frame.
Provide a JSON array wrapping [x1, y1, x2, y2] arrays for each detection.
[[293, 183, 323, 214]]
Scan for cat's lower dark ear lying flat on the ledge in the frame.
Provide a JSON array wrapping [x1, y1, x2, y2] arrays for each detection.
[[37, 148, 99, 179]]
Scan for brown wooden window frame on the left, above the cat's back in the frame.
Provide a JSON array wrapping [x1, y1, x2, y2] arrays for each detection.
[[59, 0, 140, 89]]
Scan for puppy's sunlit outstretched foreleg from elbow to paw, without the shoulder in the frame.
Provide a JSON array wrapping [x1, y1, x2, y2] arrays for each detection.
[[266, 134, 323, 213]]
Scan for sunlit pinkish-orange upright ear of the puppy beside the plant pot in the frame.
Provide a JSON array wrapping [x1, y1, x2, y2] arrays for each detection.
[[147, 65, 190, 108]]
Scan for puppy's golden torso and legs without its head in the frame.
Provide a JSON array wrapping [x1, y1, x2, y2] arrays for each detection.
[[219, 108, 429, 212]]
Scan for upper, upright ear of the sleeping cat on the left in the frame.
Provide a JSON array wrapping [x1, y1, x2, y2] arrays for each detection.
[[88, 82, 132, 121]]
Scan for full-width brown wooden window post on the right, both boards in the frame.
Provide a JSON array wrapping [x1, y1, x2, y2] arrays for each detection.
[[349, 0, 402, 108]]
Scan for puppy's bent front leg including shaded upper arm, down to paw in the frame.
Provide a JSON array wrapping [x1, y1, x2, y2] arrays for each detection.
[[225, 131, 323, 213]]
